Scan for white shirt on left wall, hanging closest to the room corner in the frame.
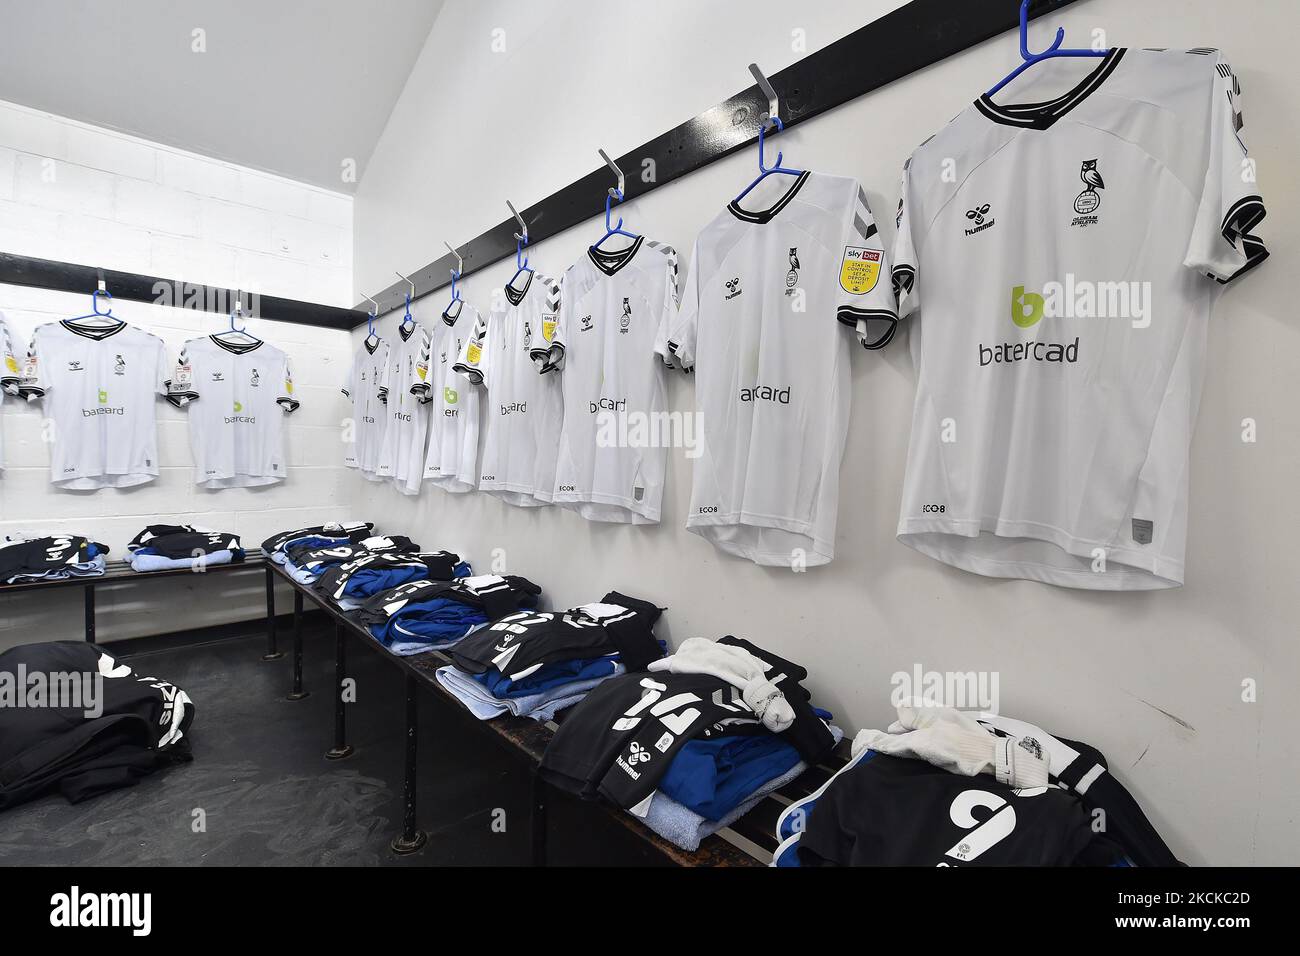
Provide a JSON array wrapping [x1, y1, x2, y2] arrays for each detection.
[[168, 336, 298, 488]]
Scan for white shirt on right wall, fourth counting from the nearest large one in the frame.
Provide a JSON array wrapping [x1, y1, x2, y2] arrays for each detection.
[[454, 272, 564, 507]]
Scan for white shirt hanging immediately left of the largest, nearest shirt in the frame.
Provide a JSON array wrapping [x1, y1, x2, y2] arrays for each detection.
[[668, 172, 897, 567]]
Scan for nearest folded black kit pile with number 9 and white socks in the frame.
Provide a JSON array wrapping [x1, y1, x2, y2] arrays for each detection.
[[772, 702, 1182, 866]]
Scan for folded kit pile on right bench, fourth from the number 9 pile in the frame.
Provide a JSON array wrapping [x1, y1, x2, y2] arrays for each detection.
[[352, 575, 542, 657]]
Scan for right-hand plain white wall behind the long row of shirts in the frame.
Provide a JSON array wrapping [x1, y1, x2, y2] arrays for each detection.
[[351, 0, 1300, 864]]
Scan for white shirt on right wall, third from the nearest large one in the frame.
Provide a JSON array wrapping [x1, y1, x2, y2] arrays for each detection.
[[543, 237, 677, 524]]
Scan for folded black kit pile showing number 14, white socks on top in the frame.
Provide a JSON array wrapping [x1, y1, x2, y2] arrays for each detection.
[[541, 637, 842, 849]]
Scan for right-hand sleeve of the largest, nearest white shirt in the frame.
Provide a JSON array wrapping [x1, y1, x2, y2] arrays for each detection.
[[1183, 59, 1269, 282]]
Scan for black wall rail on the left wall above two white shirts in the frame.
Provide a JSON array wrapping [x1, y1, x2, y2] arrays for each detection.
[[0, 252, 365, 329]]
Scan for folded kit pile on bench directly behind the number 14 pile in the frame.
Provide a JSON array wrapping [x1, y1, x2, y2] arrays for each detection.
[[436, 591, 664, 721]]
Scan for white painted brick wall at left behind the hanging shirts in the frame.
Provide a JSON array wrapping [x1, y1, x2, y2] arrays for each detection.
[[0, 101, 352, 649]]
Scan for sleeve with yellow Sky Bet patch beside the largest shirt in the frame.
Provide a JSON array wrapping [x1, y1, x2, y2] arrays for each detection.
[[836, 181, 898, 349]]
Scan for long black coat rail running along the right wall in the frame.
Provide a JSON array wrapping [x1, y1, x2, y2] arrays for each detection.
[[358, 0, 1074, 323]]
